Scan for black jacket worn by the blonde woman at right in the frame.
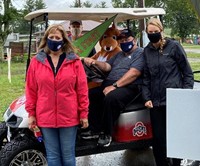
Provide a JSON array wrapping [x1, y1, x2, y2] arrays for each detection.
[[142, 39, 194, 106]]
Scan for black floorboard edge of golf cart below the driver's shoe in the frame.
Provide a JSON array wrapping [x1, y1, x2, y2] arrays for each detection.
[[76, 139, 152, 157]]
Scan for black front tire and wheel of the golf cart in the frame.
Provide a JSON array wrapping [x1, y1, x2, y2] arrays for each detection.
[[0, 137, 47, 166]]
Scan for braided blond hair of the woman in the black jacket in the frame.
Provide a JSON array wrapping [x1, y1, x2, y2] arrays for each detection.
[[146, 18, 166, 54]]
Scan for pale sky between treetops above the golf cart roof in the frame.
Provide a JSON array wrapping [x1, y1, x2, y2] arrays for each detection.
[[12, 0, 112, 9]]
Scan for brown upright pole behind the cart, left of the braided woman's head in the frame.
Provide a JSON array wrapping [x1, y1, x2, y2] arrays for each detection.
[[138, 0, 145, 47]]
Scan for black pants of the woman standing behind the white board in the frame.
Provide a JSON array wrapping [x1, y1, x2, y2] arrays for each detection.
[[150, 106, 181, 166]]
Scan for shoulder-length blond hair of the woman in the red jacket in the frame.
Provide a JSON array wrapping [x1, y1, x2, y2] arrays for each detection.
[[39, 24, 75, 53]]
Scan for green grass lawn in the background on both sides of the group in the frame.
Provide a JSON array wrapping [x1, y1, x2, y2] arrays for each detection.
[[0, 44, 200, 121]]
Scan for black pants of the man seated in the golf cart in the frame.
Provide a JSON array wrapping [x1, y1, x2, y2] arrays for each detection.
[[89, 81, 139, 135]]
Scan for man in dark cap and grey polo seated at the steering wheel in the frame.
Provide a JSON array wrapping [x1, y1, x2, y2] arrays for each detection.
[[84, 29, 144, 146]]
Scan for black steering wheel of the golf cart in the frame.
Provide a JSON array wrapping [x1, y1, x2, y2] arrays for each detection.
[[82, 60, 106, 80]]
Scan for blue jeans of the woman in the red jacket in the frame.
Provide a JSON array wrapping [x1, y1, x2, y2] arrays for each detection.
[[41, 126, 77, 166]]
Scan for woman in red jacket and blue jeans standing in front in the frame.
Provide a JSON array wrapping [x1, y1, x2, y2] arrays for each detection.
[[26, 25, 89, 166]]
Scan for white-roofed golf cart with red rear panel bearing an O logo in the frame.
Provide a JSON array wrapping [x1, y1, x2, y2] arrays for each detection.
[[0, 8, 165, 166]]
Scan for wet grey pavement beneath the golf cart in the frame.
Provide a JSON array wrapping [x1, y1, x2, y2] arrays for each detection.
[[76, 148, 155, 166]]
